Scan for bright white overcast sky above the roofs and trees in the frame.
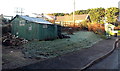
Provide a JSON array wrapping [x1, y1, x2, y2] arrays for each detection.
[[0, 0, 120, 16]]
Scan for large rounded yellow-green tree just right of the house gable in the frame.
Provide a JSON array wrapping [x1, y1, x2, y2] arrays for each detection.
[[89, 8, 105, 24]]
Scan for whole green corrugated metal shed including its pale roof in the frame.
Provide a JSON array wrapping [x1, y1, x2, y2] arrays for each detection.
[[11, 15, 58, 40]]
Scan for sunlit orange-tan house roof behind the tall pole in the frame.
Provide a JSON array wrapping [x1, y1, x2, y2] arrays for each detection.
[[56, 14, 88, 21]]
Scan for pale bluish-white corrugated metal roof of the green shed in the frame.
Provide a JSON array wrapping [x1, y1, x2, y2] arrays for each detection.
[[20, 16, 52, 24]]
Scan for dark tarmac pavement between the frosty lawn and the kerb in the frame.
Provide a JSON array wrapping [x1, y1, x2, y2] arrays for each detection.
[[17, 37, 116, 69]]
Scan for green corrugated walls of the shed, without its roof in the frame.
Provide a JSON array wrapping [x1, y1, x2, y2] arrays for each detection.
[[11, 17, 57, 40]]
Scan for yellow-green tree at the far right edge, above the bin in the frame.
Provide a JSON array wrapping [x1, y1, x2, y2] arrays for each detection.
[[105, 7, 119, 23]]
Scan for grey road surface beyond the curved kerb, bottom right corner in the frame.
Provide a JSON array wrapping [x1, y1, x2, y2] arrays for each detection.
[[88, 46, 119, 70]]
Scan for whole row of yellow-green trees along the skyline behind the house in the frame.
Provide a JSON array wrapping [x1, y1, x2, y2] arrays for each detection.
[[48, 7, 119, 24]]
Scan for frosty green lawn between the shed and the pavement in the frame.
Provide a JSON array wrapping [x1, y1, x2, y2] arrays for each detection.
[[23, 31, 102, 58]]
